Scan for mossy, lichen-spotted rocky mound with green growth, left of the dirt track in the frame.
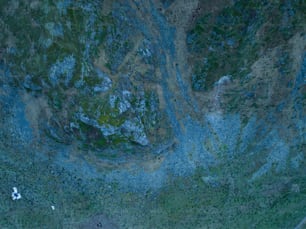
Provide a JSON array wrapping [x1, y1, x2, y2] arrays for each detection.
[[0, 0, 164, 148]]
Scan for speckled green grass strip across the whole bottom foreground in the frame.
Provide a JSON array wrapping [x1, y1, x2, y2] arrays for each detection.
[[0, 143, 306, 228]]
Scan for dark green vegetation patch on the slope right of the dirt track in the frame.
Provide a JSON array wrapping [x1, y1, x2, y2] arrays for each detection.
[[187, 0, 306, 90]]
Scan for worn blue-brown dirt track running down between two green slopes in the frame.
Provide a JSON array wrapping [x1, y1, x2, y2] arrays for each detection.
[[131, 0, 198, 138]]
